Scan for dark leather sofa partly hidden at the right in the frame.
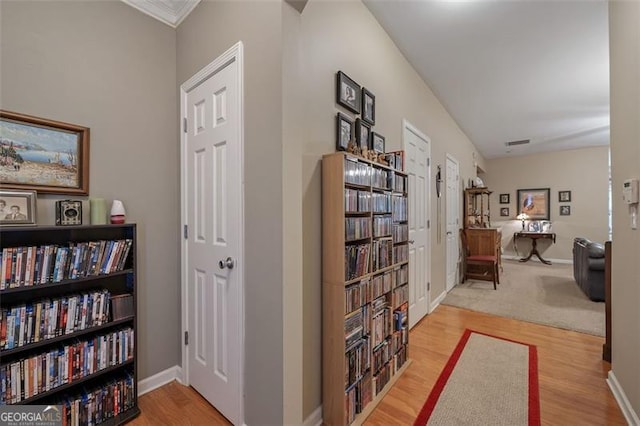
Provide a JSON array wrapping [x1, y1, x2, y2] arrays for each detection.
[[573, 238, 604, 302]]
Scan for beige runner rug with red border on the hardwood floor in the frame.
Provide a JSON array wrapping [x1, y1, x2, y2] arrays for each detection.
[[414, 330, 540, 426]]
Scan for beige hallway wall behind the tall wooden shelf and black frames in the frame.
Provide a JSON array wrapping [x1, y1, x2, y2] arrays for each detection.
[[292, 0, 483, 418]]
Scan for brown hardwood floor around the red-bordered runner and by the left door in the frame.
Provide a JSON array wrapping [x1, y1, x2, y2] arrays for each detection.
[[130, 305, 627, 426]]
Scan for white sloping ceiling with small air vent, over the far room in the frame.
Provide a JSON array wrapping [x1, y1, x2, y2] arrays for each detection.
[[364, 0, 609, 158]]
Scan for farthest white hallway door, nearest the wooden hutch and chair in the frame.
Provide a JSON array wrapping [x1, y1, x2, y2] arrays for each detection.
[[445, 154, 460, 291]]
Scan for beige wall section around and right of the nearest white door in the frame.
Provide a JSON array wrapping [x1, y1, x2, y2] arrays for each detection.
[[176, 1, 284, 425]]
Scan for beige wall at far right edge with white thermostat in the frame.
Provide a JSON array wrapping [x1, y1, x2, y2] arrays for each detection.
[[609, 1, 640, 419]]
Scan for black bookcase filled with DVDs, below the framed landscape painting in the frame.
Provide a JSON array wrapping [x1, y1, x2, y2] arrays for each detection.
[[0, 224, 140, 425]]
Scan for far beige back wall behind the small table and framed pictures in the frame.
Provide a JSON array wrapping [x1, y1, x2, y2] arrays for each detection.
[[480, 146, 609, 260]]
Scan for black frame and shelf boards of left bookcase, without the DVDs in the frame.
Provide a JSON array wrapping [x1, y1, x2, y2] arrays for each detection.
[[0, 223, 140, 425]]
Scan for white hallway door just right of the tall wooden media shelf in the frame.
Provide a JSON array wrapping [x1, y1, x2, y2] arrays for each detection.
[[402, 121, 431, 327]]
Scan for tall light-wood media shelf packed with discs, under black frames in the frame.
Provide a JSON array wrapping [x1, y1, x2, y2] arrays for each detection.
[[322, 152, 409, 426]]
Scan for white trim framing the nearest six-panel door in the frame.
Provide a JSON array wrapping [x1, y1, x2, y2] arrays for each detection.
[[179, 41, 245, 424]]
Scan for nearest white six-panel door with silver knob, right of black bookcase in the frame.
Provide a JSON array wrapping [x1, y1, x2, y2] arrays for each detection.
[[182, 45, 244, 424]]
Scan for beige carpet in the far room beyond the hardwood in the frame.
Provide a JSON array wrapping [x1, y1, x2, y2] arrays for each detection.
[[442, 260, 605, 336]]
